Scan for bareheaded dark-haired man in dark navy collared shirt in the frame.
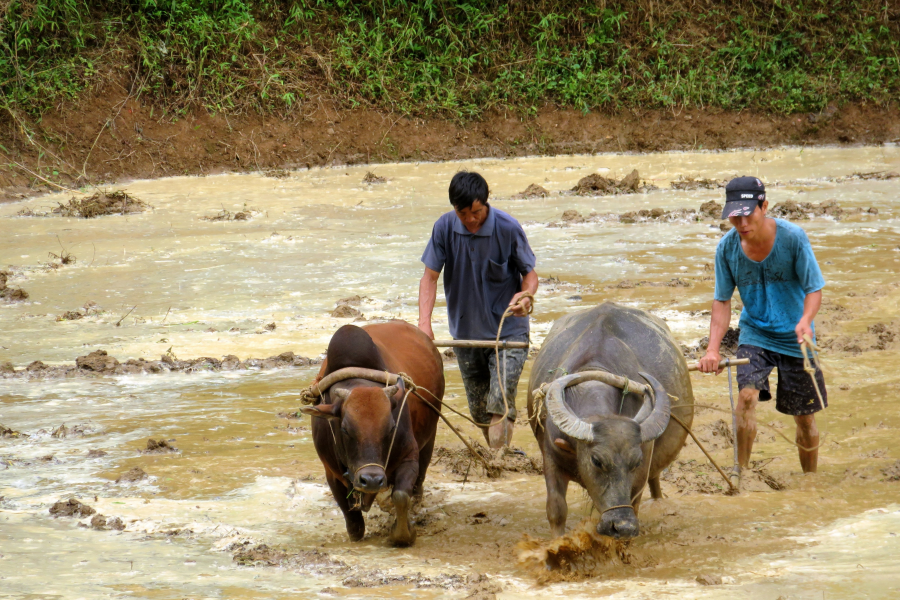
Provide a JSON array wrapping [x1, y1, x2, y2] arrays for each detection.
[[419, 171, 538, 448]]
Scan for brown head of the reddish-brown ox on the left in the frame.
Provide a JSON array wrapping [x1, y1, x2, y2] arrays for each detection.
[[302, 381, 404, 493]]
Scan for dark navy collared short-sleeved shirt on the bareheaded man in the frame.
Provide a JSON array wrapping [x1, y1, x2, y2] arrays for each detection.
[[422, 206, 535, 340]]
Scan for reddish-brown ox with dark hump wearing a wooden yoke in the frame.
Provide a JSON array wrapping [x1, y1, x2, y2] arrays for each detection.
[[303, 321, 444, 545]]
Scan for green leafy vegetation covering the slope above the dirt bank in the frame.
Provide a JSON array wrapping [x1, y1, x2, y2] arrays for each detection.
[[0, 0, 900, 118]]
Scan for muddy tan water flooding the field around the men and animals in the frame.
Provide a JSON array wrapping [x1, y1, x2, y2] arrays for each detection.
[[0, 147, 900, 598]]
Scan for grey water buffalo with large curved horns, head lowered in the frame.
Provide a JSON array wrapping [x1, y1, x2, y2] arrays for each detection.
[[528, 302, 694, 538]]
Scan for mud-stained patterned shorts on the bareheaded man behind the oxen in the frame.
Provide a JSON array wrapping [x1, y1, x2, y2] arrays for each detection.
[[455, 339, 528, 424]]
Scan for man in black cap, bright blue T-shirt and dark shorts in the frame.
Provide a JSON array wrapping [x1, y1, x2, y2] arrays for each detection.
[[700, 177, 828, 486]]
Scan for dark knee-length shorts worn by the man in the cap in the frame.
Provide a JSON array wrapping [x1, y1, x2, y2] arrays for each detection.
[[737, 345, 828, 416]]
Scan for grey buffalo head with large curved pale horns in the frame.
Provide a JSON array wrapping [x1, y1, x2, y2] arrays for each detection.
[[546, 373, 670, 539]]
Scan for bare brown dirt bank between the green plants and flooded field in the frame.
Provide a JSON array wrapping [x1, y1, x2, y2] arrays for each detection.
[[0, 88, 900, 202]]
